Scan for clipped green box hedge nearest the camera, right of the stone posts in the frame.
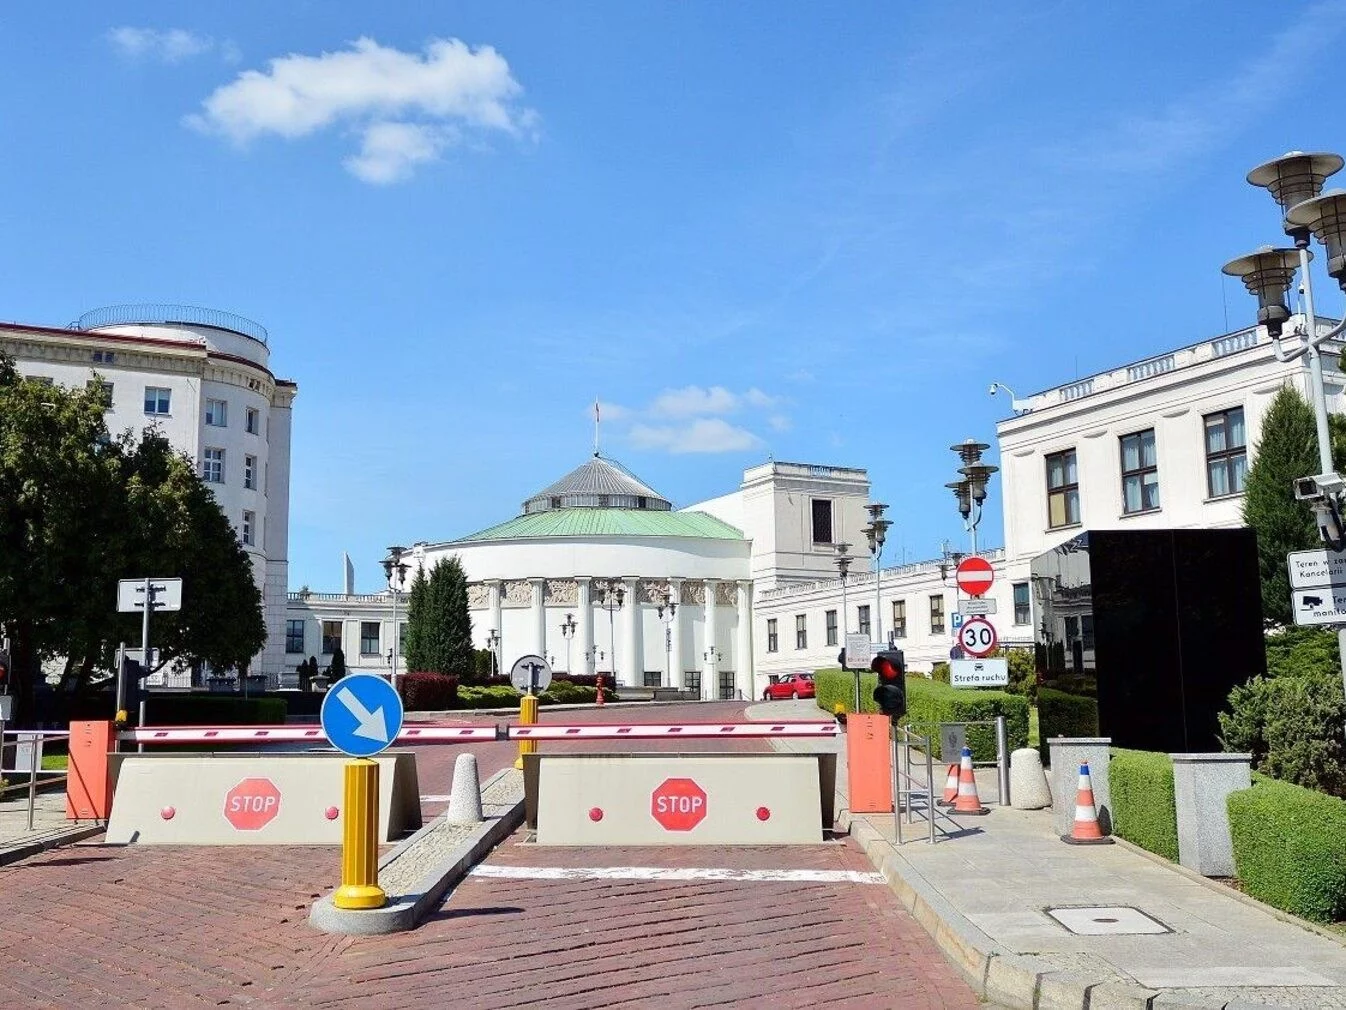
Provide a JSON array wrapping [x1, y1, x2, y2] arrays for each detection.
[[1229, 778, 1346, 922]]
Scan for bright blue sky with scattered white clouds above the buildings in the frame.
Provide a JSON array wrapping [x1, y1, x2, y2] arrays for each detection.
[[0, 0, 1346, 590]]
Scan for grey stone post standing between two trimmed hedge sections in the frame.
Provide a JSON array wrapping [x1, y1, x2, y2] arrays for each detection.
[[1170, 754, 1252, 877]]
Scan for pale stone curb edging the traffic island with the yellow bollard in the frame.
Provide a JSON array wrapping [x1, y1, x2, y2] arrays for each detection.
[[308, 768, 524, 936]]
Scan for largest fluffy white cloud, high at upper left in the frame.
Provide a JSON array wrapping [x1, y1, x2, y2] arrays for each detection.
[[186, 38, 537, 183]]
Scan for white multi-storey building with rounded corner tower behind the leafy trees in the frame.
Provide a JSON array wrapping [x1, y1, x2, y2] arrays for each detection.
[[0, 304, 299, 675]]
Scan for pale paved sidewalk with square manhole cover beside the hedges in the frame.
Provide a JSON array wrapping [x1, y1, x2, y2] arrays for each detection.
[[748, 702, 1346, 1010]]
